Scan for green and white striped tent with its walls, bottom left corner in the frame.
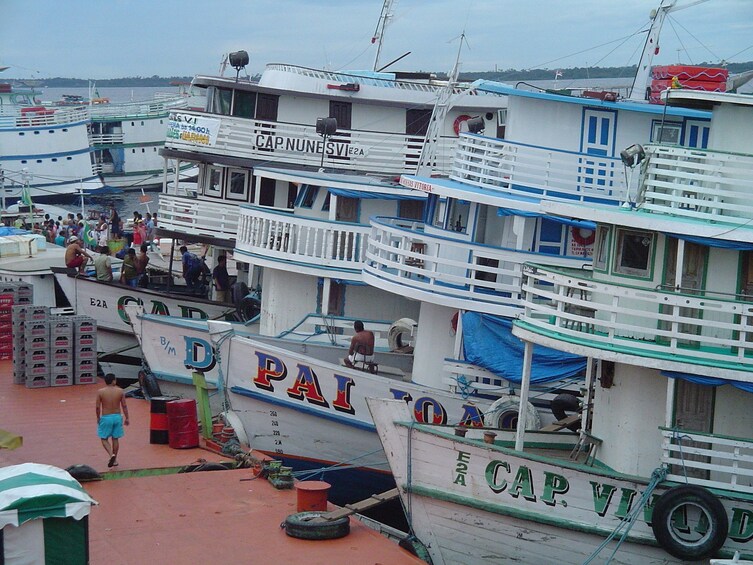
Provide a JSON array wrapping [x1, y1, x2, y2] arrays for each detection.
[[0, 463, 96, 565]]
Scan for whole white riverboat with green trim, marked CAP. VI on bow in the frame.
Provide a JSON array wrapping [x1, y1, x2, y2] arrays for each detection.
[[371, 85, 753, 564]]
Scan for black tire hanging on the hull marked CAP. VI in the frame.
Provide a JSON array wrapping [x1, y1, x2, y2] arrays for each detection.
[[651, 485, 729, 561]]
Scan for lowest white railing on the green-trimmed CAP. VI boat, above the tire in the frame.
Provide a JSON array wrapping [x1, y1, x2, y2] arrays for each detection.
[[659, 428, 753, 493]]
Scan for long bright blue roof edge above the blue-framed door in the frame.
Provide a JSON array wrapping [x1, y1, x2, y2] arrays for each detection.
[[476, 81, 711, 119]]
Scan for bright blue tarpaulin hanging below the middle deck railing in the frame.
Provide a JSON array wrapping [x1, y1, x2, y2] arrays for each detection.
[[463, 312, 586, 383]]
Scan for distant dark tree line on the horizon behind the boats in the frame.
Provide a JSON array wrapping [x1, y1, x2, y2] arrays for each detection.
[[15, 61, 753, 88]]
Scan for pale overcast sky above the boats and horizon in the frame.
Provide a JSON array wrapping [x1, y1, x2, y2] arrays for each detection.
[[0, 0, 753, 79]]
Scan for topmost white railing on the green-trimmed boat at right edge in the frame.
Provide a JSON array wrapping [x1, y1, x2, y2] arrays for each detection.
[[638, 145, 753, 225]]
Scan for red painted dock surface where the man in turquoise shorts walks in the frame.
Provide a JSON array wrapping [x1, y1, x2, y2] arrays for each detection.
[[0, 361, 423, 565]]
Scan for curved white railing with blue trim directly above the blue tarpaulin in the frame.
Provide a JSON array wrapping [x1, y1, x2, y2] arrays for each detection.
[[363, 218, 585, 316]]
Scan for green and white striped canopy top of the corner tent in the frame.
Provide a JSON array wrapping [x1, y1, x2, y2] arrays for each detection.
[[0, 463, 97, 529]]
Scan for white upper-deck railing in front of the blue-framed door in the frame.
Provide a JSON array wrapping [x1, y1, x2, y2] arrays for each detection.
[[450, 134, 638, 204]]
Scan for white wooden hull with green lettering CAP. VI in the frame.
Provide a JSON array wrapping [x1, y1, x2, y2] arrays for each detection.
[[369, 399, 753, 565]]
